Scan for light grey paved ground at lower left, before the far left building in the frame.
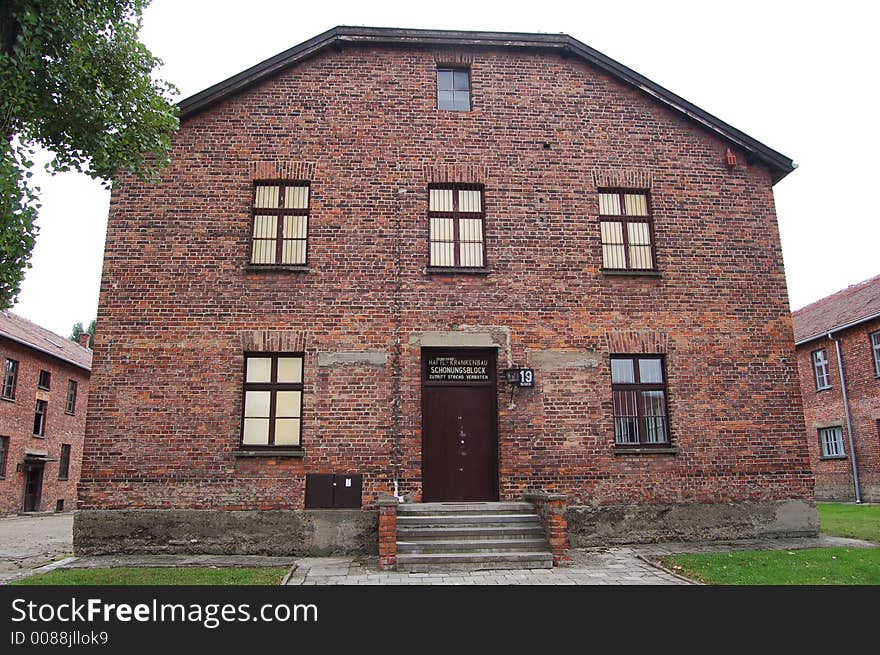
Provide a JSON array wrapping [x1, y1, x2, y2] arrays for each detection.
[[0, 512, 73, 584]]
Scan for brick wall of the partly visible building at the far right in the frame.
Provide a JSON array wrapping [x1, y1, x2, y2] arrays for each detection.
[[797, 316, 880, 503]]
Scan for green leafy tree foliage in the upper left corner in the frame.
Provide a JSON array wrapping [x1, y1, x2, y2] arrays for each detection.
[[0, 0, 177, 309]]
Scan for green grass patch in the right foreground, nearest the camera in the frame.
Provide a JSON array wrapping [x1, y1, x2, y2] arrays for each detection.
[[661, 548, 880, 585]]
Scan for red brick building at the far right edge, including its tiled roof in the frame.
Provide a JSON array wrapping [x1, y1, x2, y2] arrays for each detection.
[[792, 276, 880, 503]]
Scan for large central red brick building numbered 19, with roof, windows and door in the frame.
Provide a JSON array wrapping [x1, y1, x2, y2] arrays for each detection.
[[76, 27, 817, 552]]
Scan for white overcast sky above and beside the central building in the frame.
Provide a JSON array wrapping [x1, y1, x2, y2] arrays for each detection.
[[13, 0, 880, 336]]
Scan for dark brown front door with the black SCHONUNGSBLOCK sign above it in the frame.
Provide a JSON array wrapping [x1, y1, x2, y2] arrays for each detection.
[[422, 349, 498, 502]]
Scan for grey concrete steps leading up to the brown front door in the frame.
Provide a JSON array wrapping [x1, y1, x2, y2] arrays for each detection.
[[397, 502, 553, 573]]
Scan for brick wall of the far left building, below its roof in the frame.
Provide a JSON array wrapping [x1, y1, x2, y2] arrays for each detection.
[[0, 328, 89, 515]]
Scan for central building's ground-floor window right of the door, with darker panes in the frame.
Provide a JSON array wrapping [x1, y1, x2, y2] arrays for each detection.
[[611, 355, 669, 446]]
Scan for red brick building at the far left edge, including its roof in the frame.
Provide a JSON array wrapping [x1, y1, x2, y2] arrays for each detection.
[[0, 311, 92, 515]]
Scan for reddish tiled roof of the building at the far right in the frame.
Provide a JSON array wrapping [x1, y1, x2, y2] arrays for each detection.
[[791, 275, 880, 345]]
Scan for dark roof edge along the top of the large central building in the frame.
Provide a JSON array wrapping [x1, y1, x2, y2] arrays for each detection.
[[178, 26, 796, 184]]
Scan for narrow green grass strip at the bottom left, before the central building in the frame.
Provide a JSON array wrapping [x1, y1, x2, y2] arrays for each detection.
[[10, 566, 287, 585]]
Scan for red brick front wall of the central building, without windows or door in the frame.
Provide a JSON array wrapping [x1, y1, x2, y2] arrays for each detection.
[[80, 29, 813, 552]]
